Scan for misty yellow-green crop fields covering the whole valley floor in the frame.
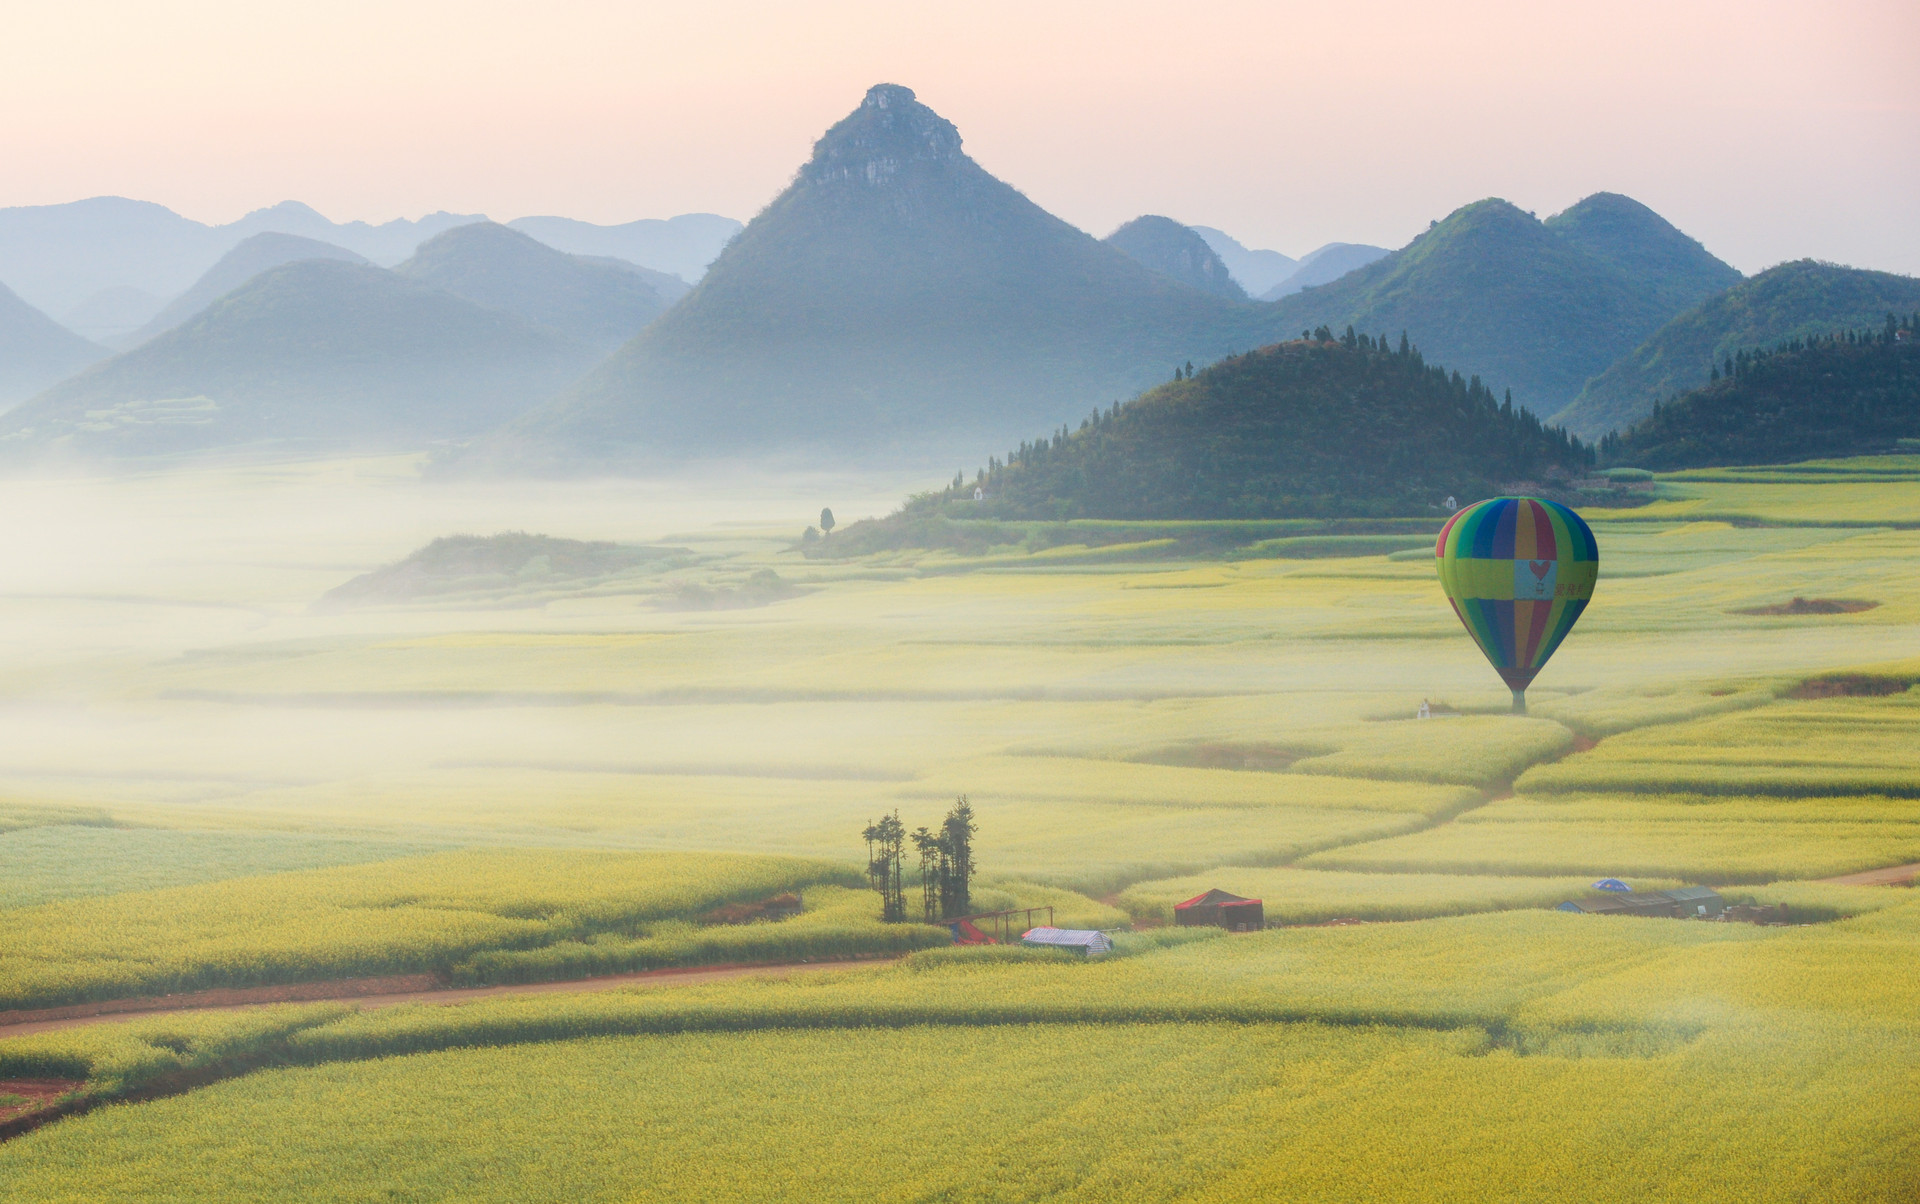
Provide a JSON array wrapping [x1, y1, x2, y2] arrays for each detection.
[[0, 457, 1920, 1202]]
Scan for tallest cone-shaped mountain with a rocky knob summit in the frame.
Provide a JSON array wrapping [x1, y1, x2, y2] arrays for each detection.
[[480, 84, 1254, 470]]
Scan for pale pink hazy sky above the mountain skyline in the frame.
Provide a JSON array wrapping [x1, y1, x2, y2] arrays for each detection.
[[11, 0, 1920, 273]]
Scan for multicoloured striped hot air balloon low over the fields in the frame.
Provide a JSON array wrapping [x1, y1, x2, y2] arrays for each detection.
[[1434, 497, 1599, 714]]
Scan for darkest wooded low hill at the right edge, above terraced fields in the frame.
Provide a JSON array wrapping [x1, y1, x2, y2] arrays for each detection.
[[1599, 313, 1920, 469]]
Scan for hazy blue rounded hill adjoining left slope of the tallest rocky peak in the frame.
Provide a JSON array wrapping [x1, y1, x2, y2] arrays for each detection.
[[394, 221, 666, 351]]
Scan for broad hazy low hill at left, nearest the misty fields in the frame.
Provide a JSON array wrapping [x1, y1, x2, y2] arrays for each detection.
[[0, 259, 593, 457]]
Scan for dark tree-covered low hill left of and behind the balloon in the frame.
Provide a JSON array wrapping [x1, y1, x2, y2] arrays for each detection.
[[908, 328, 1592, 518]]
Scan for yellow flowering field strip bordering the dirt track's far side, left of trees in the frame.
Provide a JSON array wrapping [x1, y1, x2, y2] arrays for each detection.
[[0, 849, 881, 1008]]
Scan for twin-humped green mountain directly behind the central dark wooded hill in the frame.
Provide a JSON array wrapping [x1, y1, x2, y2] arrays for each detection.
[[1275, 194, 1738, 415]]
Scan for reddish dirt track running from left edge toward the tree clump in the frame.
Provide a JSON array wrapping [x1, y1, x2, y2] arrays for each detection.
[[0, 956, 897, 1039]]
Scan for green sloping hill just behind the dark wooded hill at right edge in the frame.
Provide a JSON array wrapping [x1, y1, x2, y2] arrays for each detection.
[[1553, 259, 1920, 438]]
